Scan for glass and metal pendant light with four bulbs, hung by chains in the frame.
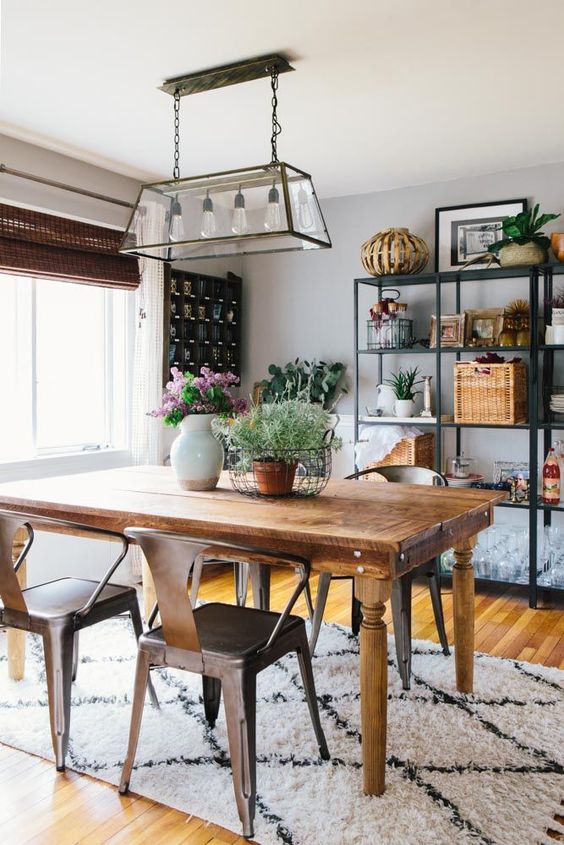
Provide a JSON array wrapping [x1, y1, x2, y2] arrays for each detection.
[[120, 55, 331, 261]]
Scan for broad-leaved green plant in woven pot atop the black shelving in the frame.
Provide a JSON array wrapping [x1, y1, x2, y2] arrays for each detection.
[[489, 203, 560, 267]]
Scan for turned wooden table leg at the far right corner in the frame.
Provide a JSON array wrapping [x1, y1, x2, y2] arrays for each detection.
[[452, 537, 476, 692]]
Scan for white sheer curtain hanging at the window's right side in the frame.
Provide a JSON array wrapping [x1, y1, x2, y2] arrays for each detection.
[[130, 204, 164, 577]]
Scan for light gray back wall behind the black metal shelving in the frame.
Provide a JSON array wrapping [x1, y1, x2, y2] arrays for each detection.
[[243, 160, 564, 412]]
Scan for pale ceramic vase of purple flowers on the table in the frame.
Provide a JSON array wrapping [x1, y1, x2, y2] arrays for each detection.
[[150, 367, 247, 490]]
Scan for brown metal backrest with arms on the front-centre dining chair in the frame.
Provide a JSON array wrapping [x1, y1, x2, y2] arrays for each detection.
[[125, 528, 309, 669]]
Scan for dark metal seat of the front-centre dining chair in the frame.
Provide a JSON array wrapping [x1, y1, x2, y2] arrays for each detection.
[[139, 602, 305, 659]]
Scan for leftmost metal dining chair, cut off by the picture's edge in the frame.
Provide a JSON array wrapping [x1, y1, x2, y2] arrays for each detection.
[[0, 512, 158, 772]]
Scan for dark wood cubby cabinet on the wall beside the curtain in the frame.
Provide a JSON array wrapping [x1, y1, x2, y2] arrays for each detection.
[[163, 267, 242, 383]]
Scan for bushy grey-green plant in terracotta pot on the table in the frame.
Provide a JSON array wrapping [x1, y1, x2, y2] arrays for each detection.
[[222, 397, 341, 496]]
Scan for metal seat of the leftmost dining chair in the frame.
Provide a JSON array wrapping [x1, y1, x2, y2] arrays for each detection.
[[18, 578, 136, 619]]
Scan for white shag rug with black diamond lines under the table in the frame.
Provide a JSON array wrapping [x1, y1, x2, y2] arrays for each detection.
[[0, 619, 564, 845]]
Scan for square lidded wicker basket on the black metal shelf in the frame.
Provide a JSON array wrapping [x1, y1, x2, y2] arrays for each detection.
[[454, 361, 527, 425]]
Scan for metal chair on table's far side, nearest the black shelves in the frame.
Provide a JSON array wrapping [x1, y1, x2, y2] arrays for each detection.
[[309, 466, 450, 689]]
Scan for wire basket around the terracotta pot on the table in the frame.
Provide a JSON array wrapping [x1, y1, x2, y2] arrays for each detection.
[[227, 445, 331, 498]]
